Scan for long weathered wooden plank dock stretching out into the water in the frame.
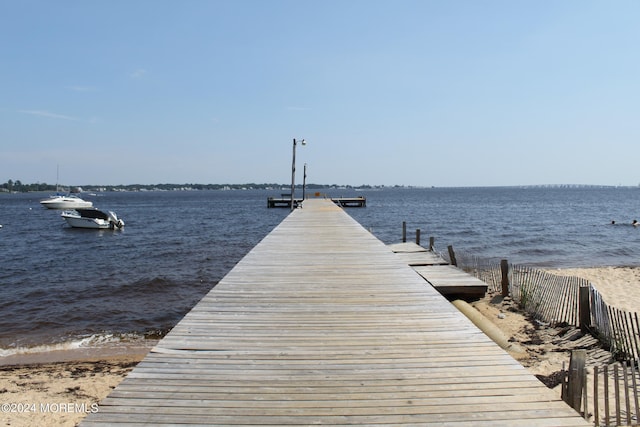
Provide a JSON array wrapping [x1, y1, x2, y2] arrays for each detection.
[[81, 199, 590, 427]]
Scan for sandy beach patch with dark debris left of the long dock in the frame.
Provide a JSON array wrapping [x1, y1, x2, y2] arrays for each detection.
[[0, 342, 154, 427]]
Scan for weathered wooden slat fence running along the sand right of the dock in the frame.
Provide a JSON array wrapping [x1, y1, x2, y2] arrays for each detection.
[[441, 244, 640, 426]]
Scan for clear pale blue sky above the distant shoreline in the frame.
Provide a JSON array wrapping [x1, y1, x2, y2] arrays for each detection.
[[0, 0, 640, 186]]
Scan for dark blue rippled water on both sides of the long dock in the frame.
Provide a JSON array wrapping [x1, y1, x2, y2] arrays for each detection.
[[0, 188, 640, 356]]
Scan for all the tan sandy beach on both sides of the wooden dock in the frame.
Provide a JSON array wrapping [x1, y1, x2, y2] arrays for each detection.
[[0, 267, 640, 426]]
